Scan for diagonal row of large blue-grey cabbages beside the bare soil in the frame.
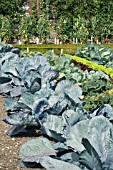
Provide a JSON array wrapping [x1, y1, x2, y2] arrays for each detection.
[[0, 44, 113, 170]]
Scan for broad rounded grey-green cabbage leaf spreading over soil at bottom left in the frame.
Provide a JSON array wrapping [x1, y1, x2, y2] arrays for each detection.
[[19, 138, 56, 162]]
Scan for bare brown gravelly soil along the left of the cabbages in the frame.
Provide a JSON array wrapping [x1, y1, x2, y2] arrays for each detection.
[[0, 95, 42, 170]]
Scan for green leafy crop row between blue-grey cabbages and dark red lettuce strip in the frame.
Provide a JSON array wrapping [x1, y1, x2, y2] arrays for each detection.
[[46, 52, 113, 111]]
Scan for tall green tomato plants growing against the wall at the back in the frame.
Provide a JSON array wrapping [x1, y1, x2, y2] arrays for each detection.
[[0, 0, 113, 43]]
